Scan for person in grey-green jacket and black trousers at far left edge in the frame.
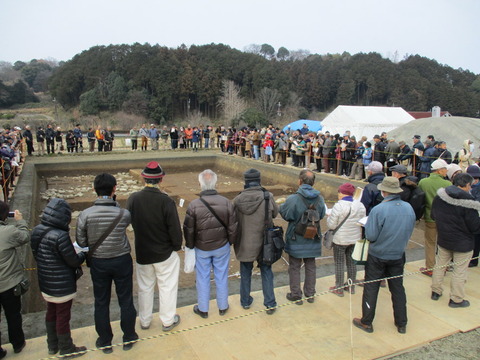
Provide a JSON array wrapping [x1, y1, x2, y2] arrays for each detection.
[[0, 201, 30, 358]]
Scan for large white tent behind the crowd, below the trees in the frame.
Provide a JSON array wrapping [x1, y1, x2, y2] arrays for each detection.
[[322, 105, 414, 140]]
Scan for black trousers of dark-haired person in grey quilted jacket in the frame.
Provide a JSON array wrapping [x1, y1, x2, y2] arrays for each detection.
[[90, 254, 138, 347]]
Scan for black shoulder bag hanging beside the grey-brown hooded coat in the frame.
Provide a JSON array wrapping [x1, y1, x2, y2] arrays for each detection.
[[259, 188, 285, 265]]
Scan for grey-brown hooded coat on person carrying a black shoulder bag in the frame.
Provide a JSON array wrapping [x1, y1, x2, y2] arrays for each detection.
[[233, 186, 278, 262]]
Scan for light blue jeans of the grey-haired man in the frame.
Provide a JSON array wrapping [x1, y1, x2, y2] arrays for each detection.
[[195, 243, 230, 312]]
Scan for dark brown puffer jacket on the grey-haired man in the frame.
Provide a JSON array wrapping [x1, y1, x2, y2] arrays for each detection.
[[183, 190, 238, 251]]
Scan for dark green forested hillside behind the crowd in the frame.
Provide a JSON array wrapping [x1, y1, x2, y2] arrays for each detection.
[[0, 43, 480, 123]]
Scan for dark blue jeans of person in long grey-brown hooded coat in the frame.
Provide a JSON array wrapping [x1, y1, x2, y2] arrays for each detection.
[[240, 261, 277, 308]]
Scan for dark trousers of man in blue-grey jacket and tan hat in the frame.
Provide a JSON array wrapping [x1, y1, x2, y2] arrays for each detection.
[[362, 254, 407, 326]]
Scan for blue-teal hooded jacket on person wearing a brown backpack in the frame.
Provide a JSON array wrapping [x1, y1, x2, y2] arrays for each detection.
[[280, 184, 326, 258]]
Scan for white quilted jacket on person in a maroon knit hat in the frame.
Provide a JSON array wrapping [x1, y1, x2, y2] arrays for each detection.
[[327, 196, 366, 245]]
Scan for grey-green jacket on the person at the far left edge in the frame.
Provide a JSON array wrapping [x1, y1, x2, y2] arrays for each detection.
[[0, 220, 30, 293]]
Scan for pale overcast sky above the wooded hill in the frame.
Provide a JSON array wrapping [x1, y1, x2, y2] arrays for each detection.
[[0, 0, 480, 74]]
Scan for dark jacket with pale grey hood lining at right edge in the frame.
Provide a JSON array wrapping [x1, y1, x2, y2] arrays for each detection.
[[431, 185, 480, 252]]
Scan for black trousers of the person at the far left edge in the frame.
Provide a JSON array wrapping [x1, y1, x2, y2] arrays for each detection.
[[0, 288, 25, 349]]
